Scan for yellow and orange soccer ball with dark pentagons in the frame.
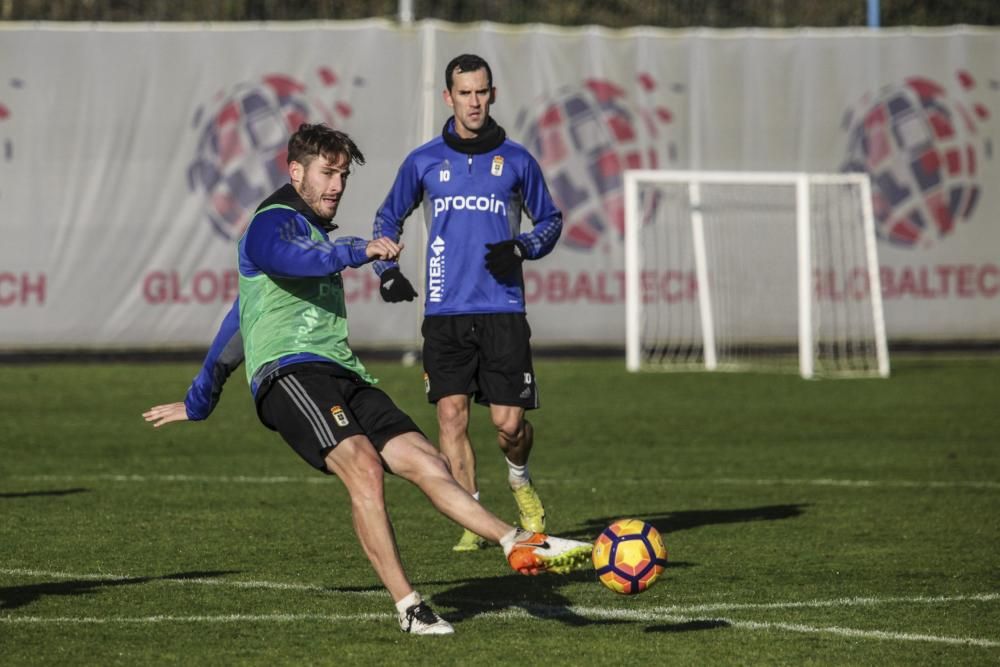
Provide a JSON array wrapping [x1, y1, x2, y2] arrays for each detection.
[[592, 519, 667, 595]]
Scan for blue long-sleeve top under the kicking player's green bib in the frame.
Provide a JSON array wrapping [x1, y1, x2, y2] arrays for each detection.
[[184, 185, 370, 421]]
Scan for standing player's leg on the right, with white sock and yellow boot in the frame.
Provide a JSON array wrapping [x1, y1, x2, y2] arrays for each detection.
[[490, 404, 545, 533]]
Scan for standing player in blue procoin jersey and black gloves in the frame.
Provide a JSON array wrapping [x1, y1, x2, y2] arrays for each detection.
[[374, 54, 562, 551]]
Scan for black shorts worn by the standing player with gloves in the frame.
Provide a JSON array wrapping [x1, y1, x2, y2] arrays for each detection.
[[421, 313, 538, 410]]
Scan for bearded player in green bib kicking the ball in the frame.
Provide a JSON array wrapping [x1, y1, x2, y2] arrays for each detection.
[[143, 125, 592, 634]]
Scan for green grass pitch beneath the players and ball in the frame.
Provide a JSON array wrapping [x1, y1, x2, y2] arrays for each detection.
[[0, 357, 1000, 665]]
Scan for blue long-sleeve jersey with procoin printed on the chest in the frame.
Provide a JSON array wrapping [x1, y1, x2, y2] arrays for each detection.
[[374, 118, 562, 315]]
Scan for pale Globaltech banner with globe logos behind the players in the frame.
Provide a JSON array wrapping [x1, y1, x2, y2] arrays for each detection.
[[0, 21, 1000, 349]]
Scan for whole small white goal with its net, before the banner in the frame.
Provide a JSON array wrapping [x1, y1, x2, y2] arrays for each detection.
[[625, 170, 889, 378]]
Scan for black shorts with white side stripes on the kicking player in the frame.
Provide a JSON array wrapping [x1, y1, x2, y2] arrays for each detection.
[[257, 364, 421, 473]]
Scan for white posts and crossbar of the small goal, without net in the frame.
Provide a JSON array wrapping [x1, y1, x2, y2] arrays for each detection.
[[624, 169, 889, 379]]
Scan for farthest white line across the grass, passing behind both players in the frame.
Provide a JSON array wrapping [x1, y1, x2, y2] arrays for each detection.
[[9, 474, 1000, 489]]
